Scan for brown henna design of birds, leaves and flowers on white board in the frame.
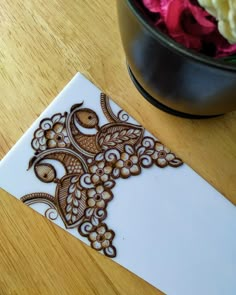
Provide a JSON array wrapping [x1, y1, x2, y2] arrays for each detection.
[[21, 94, 183, 257]]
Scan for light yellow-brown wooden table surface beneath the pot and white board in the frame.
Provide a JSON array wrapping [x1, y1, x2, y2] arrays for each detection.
[[0, 0, 236, 295]]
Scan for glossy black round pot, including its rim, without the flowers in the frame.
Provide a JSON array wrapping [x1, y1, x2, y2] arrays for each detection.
[[117, 0, 236, 118]]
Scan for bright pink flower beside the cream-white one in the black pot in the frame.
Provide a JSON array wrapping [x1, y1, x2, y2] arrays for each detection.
[[142, 0, 236, 57]]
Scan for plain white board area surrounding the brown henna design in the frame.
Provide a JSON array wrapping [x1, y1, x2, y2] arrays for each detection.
[[0, 74, 236, 295]]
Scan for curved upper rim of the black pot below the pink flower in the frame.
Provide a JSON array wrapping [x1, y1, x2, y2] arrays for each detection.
[[126, 0, 236, 72]]
